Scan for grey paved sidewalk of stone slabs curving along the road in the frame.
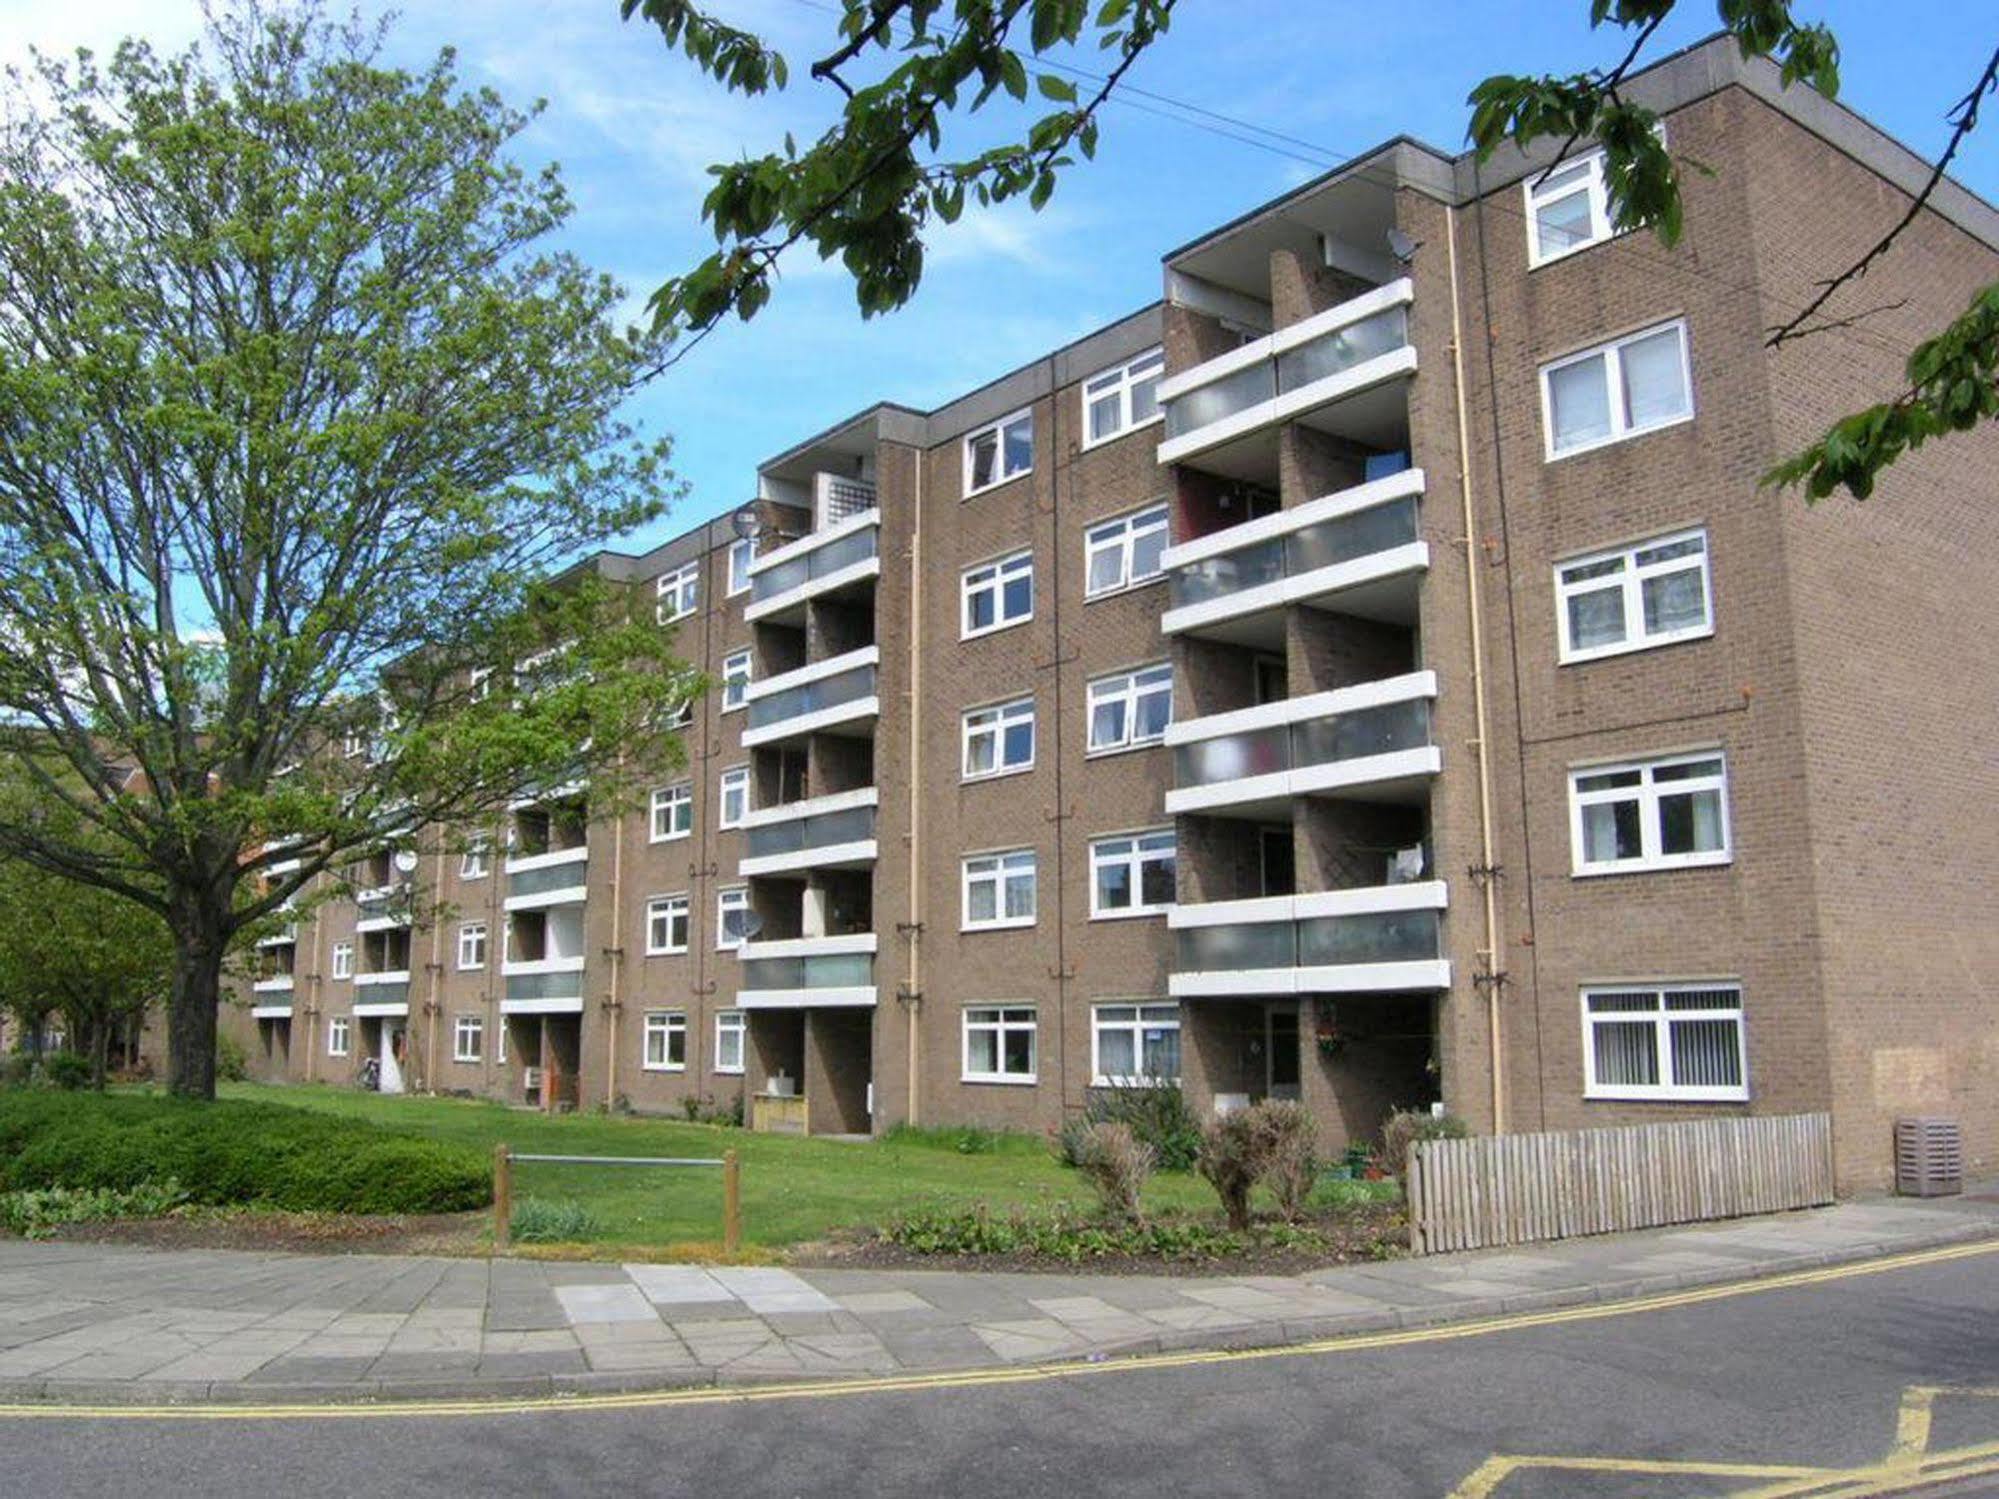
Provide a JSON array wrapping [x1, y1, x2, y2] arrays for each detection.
[[0, 1199, 1999, 1401]]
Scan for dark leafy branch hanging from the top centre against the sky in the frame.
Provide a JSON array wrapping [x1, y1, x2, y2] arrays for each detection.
[[622, 0, 1175, 358]]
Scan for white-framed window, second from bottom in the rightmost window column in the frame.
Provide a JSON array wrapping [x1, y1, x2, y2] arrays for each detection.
[[1569, 750, 1729, 875]]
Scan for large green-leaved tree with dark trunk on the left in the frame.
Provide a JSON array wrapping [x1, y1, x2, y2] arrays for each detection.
[[0, 0, 694, 1097]]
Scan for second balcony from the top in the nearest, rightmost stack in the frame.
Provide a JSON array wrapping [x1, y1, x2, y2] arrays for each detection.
[[1159, 468, 1429, 650]]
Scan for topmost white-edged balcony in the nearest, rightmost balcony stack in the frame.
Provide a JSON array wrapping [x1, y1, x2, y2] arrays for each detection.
[[1159, 278, 1415, 478]]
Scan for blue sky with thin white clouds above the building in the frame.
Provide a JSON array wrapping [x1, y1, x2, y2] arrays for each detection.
[[0, 0, 1999, 546]]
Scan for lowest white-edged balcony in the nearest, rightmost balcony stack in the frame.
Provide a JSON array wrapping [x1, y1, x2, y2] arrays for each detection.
[[1165, 879, 1451, 999]]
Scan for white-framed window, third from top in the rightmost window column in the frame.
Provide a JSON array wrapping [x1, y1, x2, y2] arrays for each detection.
[[1555, 532, 1715, 664]]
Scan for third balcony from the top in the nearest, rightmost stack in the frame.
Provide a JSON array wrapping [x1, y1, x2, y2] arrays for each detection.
[[1165, 672, 1441, 819]]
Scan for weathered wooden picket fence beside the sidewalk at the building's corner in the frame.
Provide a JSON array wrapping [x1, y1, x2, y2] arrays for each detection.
[[1407, 1113, 1833, 1255]]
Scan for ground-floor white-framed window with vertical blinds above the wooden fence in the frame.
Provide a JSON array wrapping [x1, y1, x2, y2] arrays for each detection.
[[1583, 981, 1749, 1103]]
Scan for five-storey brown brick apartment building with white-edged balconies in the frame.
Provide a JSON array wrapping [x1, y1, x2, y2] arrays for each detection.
[[226, 40, 1999, 1185]]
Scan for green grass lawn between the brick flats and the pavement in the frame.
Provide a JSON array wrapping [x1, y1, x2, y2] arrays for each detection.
[[222, 1083, 1215, 1247]]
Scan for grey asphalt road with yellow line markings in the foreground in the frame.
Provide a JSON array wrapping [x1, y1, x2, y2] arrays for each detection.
[[11, 1251, 1999, 1499]]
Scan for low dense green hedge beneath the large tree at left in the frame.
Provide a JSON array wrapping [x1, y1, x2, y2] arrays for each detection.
[[0, 1089, 492, 1213]]
